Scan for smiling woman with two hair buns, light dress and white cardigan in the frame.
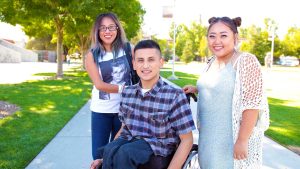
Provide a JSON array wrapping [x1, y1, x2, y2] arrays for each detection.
[[183, 17, 269, 168]]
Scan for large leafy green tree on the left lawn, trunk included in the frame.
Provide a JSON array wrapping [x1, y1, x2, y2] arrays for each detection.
[[0, 0, 145, 77]]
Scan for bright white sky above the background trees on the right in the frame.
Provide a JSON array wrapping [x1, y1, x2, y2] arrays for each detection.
[[140, 0, 300, 38]]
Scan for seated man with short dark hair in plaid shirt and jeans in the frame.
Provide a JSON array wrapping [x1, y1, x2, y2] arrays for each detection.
[[91, 40, 195, 169]]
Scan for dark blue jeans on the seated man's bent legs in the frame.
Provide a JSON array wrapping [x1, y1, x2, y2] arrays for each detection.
[[102, 138, 153, 169]]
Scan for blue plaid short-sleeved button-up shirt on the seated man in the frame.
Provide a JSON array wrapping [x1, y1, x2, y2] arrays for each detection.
[[119, 78, 195, 156]]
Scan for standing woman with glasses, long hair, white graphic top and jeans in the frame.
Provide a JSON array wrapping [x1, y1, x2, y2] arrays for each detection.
[[85, 13, 132, 159]]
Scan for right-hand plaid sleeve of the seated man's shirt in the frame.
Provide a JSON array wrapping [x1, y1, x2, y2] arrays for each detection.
[[170, 89, 195, 135]]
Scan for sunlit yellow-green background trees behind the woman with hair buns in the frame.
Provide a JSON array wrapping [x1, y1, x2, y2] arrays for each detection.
[[154, 18, 300, 64]]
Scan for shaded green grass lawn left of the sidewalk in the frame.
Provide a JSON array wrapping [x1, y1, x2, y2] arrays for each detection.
[[0, 67, 91, 169]]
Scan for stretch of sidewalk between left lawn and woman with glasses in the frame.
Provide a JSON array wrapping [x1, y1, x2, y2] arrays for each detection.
[[26, 101, 92, 169]]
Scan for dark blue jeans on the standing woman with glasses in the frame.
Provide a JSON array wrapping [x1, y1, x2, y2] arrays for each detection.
[[91, 112, 121, 160]]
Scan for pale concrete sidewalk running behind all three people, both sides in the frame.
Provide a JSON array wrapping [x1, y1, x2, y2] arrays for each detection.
[[26, 86, 300, 169]]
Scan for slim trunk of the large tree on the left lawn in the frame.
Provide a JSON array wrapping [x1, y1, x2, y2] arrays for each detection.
[[55, 16, 63, 78]]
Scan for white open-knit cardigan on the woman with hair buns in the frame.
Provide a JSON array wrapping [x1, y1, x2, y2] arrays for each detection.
[[198, 53, 269, 169]]
